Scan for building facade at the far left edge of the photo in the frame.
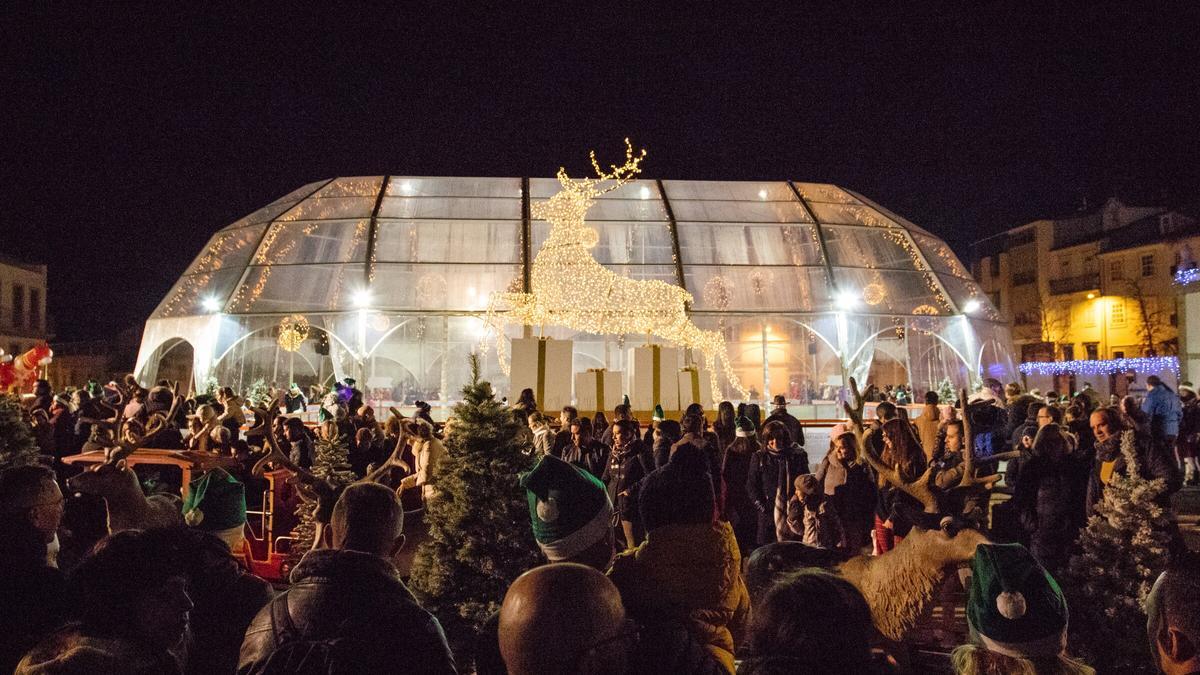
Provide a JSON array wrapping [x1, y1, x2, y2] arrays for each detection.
[[0, 255, 49, 354]]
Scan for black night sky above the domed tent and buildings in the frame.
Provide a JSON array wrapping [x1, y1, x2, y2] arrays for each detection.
[[0, 4, 1200, 339]]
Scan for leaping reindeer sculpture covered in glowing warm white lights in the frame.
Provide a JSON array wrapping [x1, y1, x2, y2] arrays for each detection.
[[485, 138, 749, 398]]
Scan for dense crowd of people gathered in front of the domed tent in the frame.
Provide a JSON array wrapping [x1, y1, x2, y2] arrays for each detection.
[[0, 369, 1200, 674]]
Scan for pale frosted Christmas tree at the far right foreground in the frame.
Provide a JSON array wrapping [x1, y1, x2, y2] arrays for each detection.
[[1064, 431, 1170, 673]]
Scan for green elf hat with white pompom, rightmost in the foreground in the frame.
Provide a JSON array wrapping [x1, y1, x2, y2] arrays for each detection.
[[967, 544, 1067, 658]]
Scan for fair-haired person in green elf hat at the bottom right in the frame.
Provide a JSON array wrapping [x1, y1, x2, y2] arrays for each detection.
[[950, 544, 1096, 675]]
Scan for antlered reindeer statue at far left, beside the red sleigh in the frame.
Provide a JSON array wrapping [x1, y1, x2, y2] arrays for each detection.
[[67, 413, 184, 532]]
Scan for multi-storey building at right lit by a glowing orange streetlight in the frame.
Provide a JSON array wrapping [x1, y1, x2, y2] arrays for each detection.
[[972, 198, 1200, 394]]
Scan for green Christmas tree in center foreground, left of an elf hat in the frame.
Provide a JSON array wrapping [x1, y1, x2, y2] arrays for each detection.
[[412, 356, 541, 662]]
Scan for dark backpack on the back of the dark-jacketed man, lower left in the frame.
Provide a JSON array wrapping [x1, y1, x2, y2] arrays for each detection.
[[254, 593, 378, 675]]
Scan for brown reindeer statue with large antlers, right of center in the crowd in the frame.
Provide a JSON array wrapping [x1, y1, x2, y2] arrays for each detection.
[[836, 378, 1016, 640]]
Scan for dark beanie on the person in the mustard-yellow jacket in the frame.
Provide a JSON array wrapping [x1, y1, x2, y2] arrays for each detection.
[[637, 443, 716, 532]]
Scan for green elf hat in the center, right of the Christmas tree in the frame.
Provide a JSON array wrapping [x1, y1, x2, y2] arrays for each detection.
[[521, 455, 612, 562]]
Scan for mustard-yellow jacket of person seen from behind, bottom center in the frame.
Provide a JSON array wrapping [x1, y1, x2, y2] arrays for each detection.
[[608, 521, 750, 673]]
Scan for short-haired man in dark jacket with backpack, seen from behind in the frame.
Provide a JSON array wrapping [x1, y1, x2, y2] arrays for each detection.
[[238, 483, 455, 674]]
